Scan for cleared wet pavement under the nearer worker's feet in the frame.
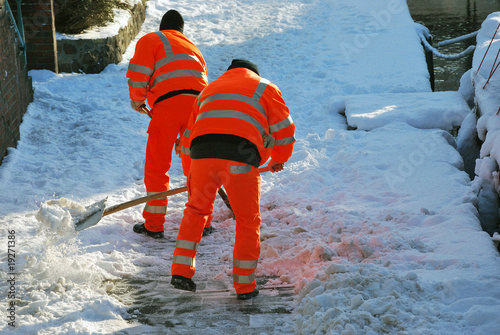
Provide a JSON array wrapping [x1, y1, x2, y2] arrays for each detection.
[[109, 233, 296, 334]]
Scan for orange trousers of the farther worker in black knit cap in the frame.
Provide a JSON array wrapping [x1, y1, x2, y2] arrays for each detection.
[[142, 94, 196, 232]]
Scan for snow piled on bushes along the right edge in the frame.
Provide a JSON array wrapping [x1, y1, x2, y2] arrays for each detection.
[[459, 12, 500, 235]]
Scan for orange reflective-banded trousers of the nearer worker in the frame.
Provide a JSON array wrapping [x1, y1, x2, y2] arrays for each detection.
[[171, 158, 261, 294]]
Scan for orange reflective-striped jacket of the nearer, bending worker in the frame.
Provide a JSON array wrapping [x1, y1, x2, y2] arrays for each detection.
[[181, 68, 295, 165]]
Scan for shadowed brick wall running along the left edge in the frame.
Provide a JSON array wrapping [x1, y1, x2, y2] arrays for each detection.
[[0, 0, 33, 162]]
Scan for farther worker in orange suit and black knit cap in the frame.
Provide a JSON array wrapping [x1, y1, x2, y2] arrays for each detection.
[[127, 10, 208, 238]]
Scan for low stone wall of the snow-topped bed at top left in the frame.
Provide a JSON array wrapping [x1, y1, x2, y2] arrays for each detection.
[[57, 0, 146, 73]]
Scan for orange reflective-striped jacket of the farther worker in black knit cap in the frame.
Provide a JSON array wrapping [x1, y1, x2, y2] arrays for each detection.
[[127, 30, 208, 106]]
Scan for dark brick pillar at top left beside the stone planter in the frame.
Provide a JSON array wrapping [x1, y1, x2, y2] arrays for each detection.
[[8, 0, 59, 73]]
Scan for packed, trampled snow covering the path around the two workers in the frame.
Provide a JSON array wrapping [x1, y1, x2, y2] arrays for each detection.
[[0, 0, 500, 335]]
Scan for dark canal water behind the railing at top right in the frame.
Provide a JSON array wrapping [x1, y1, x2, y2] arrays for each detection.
[[407, 0, 500, 91]]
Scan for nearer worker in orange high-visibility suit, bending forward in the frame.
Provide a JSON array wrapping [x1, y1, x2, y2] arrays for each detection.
[[171, 59, 295, 300]]
